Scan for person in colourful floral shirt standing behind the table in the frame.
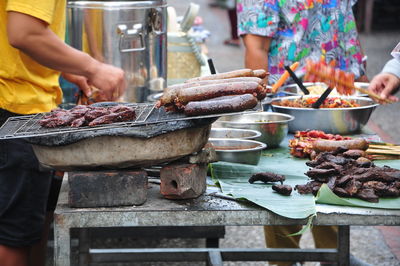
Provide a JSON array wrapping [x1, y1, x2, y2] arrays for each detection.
[[237, 0, 368, 265]]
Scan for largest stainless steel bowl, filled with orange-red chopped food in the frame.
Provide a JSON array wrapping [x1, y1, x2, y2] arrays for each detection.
[[271, 96, 378, 134]]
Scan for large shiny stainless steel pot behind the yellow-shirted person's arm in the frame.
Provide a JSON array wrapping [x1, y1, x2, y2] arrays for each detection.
[[67, 0, 167, 102]]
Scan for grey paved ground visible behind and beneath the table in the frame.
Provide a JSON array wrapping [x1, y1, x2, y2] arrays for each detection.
[[48, 0, 400, 266]]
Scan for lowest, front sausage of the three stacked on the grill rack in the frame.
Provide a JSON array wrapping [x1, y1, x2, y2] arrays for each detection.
[[184, 94, 258, 116]]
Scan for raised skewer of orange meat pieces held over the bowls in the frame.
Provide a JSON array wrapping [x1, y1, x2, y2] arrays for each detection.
[[304, 60, 393, 103]]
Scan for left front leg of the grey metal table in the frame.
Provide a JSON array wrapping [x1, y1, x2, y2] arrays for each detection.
[[54, 224, 71, 266]]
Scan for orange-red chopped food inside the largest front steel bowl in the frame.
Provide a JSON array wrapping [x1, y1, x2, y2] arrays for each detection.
[[275, 97, 360, 108]]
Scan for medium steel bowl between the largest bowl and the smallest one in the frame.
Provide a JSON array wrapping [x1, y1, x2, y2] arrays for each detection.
[[218, 112, 294, 148]]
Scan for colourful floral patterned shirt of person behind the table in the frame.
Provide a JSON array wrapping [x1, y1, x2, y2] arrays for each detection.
[[237, 0, 365, 83]]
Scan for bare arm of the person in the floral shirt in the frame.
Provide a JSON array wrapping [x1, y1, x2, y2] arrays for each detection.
[[243, 34, 271, 78]]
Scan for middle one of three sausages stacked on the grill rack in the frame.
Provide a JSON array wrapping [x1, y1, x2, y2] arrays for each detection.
[[175, 82, 264, 104]]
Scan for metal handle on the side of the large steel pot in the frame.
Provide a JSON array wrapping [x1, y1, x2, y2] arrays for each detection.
[[117, 23, 146, 53]]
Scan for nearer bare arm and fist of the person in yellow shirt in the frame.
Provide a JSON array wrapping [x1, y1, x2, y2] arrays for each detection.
[[7, 11, 125, 100]]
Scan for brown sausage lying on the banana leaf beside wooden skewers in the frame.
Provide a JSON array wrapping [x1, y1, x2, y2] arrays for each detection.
[[313, 138, 368, 152]]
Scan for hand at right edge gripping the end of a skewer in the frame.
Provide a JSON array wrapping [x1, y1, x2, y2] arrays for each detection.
[[368, 73, 400, 101]]
